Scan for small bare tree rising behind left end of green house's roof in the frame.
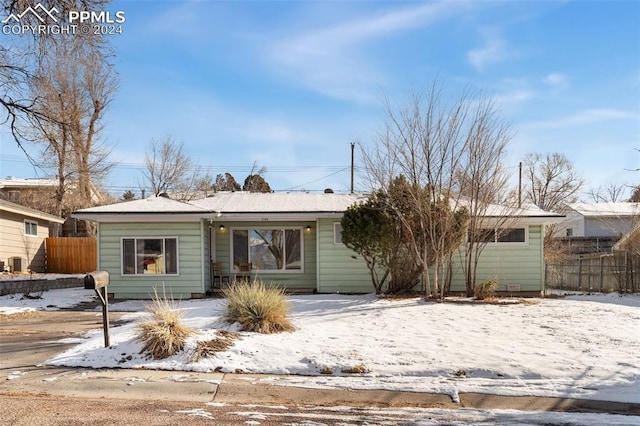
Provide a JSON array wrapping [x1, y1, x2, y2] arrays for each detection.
[[143, 136, 198, 200]]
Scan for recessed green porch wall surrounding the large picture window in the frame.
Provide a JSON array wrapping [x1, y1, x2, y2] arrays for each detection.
[[211, 221, 316, 289]]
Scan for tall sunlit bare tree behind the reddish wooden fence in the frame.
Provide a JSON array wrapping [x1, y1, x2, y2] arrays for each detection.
[[25, 36, 117, 214]]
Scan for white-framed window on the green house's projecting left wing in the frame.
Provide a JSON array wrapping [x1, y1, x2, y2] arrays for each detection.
[[122, 238, 178, 275]]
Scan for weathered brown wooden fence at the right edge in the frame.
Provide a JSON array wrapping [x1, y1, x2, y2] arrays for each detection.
[[545, 252, 640, 293]]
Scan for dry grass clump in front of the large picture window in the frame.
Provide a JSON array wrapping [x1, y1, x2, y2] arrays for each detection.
[[223, 279, 295, 334]]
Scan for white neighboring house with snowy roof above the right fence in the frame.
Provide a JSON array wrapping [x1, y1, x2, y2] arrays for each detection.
[[554, 203, 640, 239]]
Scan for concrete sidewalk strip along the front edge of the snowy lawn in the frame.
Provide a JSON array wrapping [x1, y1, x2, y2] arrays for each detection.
[[0, 367, 640, 415]]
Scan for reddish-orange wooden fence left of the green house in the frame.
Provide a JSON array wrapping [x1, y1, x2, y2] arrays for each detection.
[[45, 237, 97, 274]]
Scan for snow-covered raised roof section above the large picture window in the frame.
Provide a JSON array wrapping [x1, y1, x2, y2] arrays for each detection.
[[191, 191, 365, 213]]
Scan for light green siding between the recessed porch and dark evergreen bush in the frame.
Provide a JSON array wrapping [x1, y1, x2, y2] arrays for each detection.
[[318, 219, 374, 293]]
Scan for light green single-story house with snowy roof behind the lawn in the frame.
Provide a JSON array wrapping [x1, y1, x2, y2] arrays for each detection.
[[73, 192, 561, 298]]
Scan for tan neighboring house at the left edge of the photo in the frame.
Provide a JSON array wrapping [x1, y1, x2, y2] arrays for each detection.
[[0, 199, 64, 272]]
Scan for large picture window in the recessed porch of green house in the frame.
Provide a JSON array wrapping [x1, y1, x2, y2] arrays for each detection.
[[232, 228, 302, 272]]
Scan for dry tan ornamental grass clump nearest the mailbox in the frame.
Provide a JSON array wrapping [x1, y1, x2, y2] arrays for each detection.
[[138, 288, 195, 359]]
